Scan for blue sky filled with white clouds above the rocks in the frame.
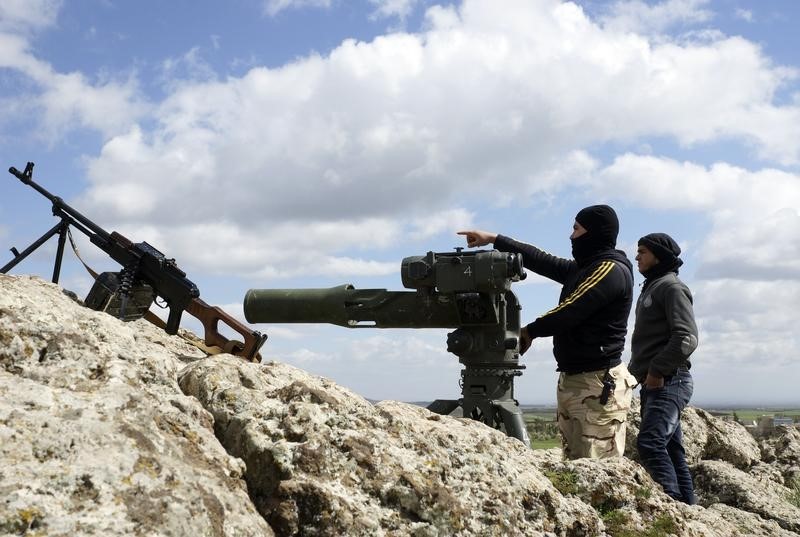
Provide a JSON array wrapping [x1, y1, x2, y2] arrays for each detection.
[[0, 0, 800, 406]]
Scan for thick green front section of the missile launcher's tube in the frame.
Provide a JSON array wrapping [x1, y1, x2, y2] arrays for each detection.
[[244, 284, 354, 326]]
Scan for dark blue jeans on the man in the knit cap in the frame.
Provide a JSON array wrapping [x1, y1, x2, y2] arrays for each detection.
[[636, 368, 697, 505]]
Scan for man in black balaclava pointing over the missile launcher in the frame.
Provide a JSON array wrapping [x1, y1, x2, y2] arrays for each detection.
[[458, 205, 636, 459]]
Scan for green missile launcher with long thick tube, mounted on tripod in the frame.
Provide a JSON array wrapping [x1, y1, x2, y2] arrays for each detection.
[[244, 248, 530, 445]]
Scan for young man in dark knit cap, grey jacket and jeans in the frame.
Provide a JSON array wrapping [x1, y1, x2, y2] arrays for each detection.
[[628, 233, 697, 504]]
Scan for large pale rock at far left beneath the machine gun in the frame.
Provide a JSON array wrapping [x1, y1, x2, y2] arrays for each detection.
[[0, 275, 272, 537]]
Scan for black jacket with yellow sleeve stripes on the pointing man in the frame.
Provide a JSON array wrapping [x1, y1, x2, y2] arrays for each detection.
[[494, 235, 633, 373]]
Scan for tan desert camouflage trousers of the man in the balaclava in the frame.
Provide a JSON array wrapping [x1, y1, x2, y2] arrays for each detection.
[[557, 364, 636, 459]]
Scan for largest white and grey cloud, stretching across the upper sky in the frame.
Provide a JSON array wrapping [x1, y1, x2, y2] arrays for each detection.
[[53, 0, 800, 277]]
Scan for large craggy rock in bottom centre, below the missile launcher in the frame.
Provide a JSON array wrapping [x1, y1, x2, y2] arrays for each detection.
[[180, 357, 600, 536]]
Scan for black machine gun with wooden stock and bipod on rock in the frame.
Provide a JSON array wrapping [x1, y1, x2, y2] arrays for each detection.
[[0, 162, 267, 361]]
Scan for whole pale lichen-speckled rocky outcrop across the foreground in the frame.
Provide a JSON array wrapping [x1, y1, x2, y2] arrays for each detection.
[[0, 275, 800, 537]]
